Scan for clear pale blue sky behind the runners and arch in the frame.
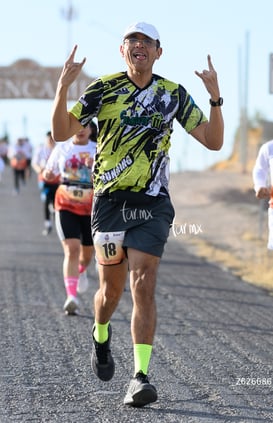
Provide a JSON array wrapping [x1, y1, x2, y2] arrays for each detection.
[[0, 0, 273, 171]]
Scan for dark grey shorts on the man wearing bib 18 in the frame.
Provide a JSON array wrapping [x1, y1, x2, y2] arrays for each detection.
[[91, 191, 174, 257]]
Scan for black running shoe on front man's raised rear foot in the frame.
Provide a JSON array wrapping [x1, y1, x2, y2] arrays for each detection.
[[91, 325, 115, 382]]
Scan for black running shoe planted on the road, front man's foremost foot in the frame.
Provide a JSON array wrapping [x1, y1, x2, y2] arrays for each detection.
[[124, 372, 157, 407]]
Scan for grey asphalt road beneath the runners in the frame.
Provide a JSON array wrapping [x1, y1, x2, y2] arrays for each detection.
[[0, 169, 273, 423]]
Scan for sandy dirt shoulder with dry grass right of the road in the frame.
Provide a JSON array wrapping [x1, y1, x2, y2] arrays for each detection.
[[170, 170, 273, 290]]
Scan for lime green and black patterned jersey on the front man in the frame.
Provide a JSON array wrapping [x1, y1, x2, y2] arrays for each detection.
[[70, 72, 207, 196]]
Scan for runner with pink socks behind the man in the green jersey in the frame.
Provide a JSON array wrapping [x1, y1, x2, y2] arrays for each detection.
[[43, 121, 97, 314]]
